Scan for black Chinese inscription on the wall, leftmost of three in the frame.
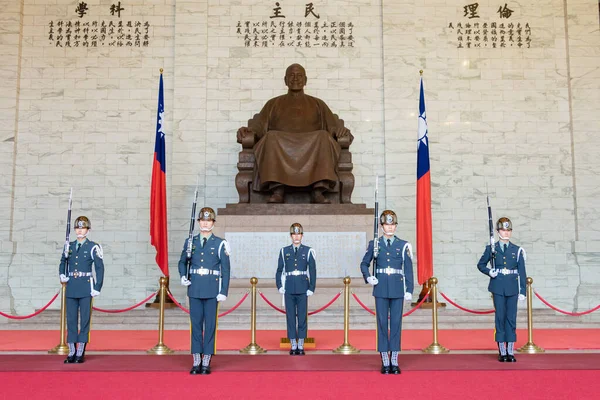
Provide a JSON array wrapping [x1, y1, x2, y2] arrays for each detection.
[[48, 1, 150, 48]]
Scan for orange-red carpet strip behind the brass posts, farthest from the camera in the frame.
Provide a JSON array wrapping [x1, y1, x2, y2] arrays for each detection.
[[0, 329, 600, 351]]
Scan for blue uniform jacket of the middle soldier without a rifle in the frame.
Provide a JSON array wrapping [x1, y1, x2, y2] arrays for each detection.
[[275, 244, 317, 294]]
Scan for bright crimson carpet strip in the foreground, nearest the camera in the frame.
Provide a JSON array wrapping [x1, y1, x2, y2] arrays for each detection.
[[0, 370, 600, 400]]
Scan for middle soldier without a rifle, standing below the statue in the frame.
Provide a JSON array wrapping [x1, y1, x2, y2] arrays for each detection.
[[275, 222, 317, 356]]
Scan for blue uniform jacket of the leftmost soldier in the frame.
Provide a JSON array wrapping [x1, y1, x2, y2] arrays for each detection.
[[58, 239, 104, 298]]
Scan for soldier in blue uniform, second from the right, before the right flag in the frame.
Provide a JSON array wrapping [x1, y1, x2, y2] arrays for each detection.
[[360, 210, 414, 375]]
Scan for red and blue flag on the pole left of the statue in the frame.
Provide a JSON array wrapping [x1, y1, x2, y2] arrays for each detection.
[[150, 72, 169, 276]]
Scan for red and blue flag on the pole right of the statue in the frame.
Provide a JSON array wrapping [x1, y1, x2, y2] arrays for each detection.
[[417, 78, 433, 285]]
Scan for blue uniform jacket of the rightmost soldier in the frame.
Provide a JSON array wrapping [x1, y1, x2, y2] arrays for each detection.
[[477, 242, 527, 296]]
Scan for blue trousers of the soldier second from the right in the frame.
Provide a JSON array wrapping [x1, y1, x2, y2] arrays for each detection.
[[375, 297, 404, 353]]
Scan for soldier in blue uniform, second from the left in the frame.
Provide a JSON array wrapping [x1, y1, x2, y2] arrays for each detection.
[[179, 207, 231, 375]]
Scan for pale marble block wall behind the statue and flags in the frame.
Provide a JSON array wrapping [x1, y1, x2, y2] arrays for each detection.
[[0, 0, 600, 313]]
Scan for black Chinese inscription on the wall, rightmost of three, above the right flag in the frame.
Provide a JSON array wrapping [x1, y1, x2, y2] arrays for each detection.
[[448, 3, 531, 49]]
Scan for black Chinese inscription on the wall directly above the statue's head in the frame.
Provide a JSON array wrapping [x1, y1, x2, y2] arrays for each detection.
[[236, 2, 354, 48]]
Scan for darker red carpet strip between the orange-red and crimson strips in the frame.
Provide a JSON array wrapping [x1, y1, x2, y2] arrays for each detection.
[[0, 352, 600, 372]]
